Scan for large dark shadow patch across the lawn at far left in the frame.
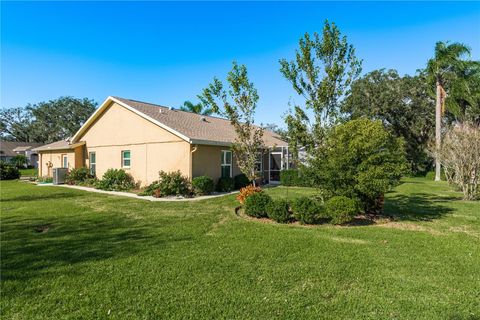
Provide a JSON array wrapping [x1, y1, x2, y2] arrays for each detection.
[[1, 214, 192, 281]]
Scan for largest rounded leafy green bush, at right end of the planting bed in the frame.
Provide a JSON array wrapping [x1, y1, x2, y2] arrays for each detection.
[[309, 119, 408, 213]]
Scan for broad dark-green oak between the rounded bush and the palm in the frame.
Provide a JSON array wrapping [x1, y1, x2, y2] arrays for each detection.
[[342, 69, 435, 173]]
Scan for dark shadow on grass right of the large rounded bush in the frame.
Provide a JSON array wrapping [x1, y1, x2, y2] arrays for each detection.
[[385, 193, 458, 221]]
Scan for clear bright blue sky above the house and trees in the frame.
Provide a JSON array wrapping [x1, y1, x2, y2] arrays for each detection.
[[0, 1, 480, 124]]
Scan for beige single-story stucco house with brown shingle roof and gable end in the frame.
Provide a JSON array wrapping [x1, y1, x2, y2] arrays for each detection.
[[36, 97, 289, 185]]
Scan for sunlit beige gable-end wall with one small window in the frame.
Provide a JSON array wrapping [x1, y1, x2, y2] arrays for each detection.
[[79, 103, 191, 185]]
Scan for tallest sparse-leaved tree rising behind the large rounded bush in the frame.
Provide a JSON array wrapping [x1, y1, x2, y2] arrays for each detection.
[[280, 21, 361, 154]]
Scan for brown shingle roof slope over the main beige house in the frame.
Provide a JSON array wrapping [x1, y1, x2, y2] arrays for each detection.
[[113, 97, 288, 146]]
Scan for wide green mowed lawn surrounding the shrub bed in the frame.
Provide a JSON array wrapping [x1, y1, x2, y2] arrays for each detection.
[[0, 179, 480, 319]]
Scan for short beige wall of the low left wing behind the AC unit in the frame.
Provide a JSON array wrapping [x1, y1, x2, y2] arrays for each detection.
[[38, 146, 84, 177]]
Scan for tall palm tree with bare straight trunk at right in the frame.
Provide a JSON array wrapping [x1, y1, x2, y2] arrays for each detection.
[[427, 41, 470, 181]]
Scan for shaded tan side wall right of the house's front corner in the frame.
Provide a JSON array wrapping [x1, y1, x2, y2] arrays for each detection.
[[192, 145, 240, 181]]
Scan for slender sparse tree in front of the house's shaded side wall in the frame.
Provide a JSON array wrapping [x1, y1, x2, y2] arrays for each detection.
[[198, 62, 264, 185]]
